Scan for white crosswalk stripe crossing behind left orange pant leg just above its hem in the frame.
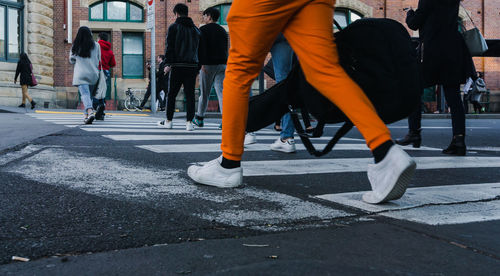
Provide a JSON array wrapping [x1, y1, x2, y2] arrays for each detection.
[[136, 143, 441, 153]]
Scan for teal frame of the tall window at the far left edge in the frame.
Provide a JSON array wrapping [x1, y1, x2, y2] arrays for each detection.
[[0, 0, 24, 62]]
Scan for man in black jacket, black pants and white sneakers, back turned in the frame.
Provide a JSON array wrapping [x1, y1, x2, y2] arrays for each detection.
[[158, 4, 200, 131]]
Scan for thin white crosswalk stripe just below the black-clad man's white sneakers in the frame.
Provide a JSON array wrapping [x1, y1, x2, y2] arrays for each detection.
[[103, 134, 364, 141]]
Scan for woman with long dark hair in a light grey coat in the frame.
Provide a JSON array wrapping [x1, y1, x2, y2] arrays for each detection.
[[69, 26, 101, 124]]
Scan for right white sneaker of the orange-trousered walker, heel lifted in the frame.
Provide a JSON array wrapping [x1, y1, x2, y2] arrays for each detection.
[[363, 145, 417, 204]]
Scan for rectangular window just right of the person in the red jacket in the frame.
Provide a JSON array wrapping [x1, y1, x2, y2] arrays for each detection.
[[122, 33, 144, 79]]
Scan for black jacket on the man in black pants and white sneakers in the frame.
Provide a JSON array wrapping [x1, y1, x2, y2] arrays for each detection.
[[165, 17, 200, 67]]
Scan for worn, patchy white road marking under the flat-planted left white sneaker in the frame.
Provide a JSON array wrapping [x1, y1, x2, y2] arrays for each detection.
[[2, 148, 354, 231]]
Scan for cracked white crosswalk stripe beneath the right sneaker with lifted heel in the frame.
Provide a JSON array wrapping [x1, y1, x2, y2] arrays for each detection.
[[315, 183, 500, 225]]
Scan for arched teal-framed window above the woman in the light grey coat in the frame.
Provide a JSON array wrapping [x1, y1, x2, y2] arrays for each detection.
[[89, 0, 144, 22]]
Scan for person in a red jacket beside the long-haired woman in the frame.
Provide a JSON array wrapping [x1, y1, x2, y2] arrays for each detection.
[[92, 33, 116, 120]]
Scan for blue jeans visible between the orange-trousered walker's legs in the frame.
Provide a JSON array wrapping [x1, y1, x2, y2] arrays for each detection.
[[271, 38, 295, 140]]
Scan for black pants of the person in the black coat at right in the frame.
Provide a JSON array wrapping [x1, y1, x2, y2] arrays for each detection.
[[408, 85, 465, 135]]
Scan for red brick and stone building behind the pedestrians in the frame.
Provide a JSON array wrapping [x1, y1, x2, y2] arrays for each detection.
[[0, 0, 500, 109]]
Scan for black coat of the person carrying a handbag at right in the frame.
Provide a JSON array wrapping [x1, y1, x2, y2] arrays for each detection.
[[406, 0, 472, 87]]
